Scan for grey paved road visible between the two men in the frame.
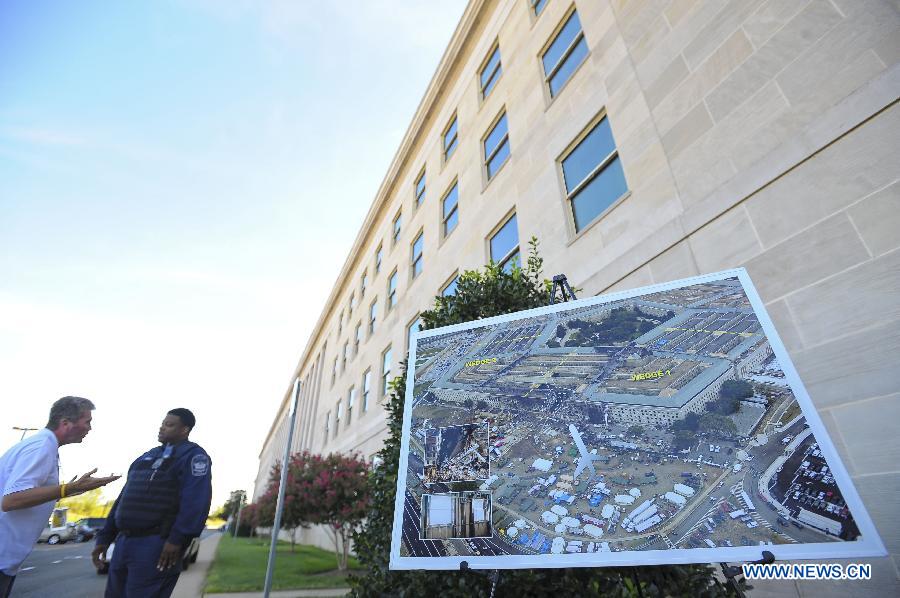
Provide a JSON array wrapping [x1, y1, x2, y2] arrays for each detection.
[[11, 530, 215, 598]]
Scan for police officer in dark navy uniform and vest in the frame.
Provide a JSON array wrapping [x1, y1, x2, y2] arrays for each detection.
[[91, 408, 212, 598]]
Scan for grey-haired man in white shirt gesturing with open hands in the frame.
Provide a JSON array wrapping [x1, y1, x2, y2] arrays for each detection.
[[0, 397, 120, 598]]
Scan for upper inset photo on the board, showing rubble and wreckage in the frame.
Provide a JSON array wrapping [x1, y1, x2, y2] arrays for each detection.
[[422, 423, 490, 484]]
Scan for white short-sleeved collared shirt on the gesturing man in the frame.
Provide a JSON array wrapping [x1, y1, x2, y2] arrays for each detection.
[[0, 428, 59, 575]]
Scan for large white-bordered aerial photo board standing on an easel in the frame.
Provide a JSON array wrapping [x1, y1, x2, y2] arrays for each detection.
[[390, 269, 885, 569]]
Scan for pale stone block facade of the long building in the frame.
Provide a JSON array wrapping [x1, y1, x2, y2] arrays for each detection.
[[256, 0, 900, 596]]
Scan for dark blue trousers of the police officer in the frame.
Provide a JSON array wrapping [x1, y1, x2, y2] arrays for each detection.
[[106, 534, 181, 598]]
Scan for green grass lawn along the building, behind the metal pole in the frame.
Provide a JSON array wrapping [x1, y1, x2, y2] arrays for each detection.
[[206, 535, 360, 593]]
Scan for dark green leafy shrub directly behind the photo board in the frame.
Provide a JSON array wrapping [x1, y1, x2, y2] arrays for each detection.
[[350, 238, 724, 598]]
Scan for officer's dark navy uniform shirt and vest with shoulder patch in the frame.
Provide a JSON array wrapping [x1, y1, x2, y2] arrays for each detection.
[[97, 441, 212, 546]]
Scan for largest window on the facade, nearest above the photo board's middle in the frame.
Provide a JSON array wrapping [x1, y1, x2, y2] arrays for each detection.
[[562, 116, 628, 232]]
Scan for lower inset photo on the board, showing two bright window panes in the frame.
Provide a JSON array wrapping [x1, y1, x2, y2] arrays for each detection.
[[421, 492, 494, 540]]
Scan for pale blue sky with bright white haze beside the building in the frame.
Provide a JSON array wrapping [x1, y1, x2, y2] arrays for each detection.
[[0, 0, 464, 502]]
